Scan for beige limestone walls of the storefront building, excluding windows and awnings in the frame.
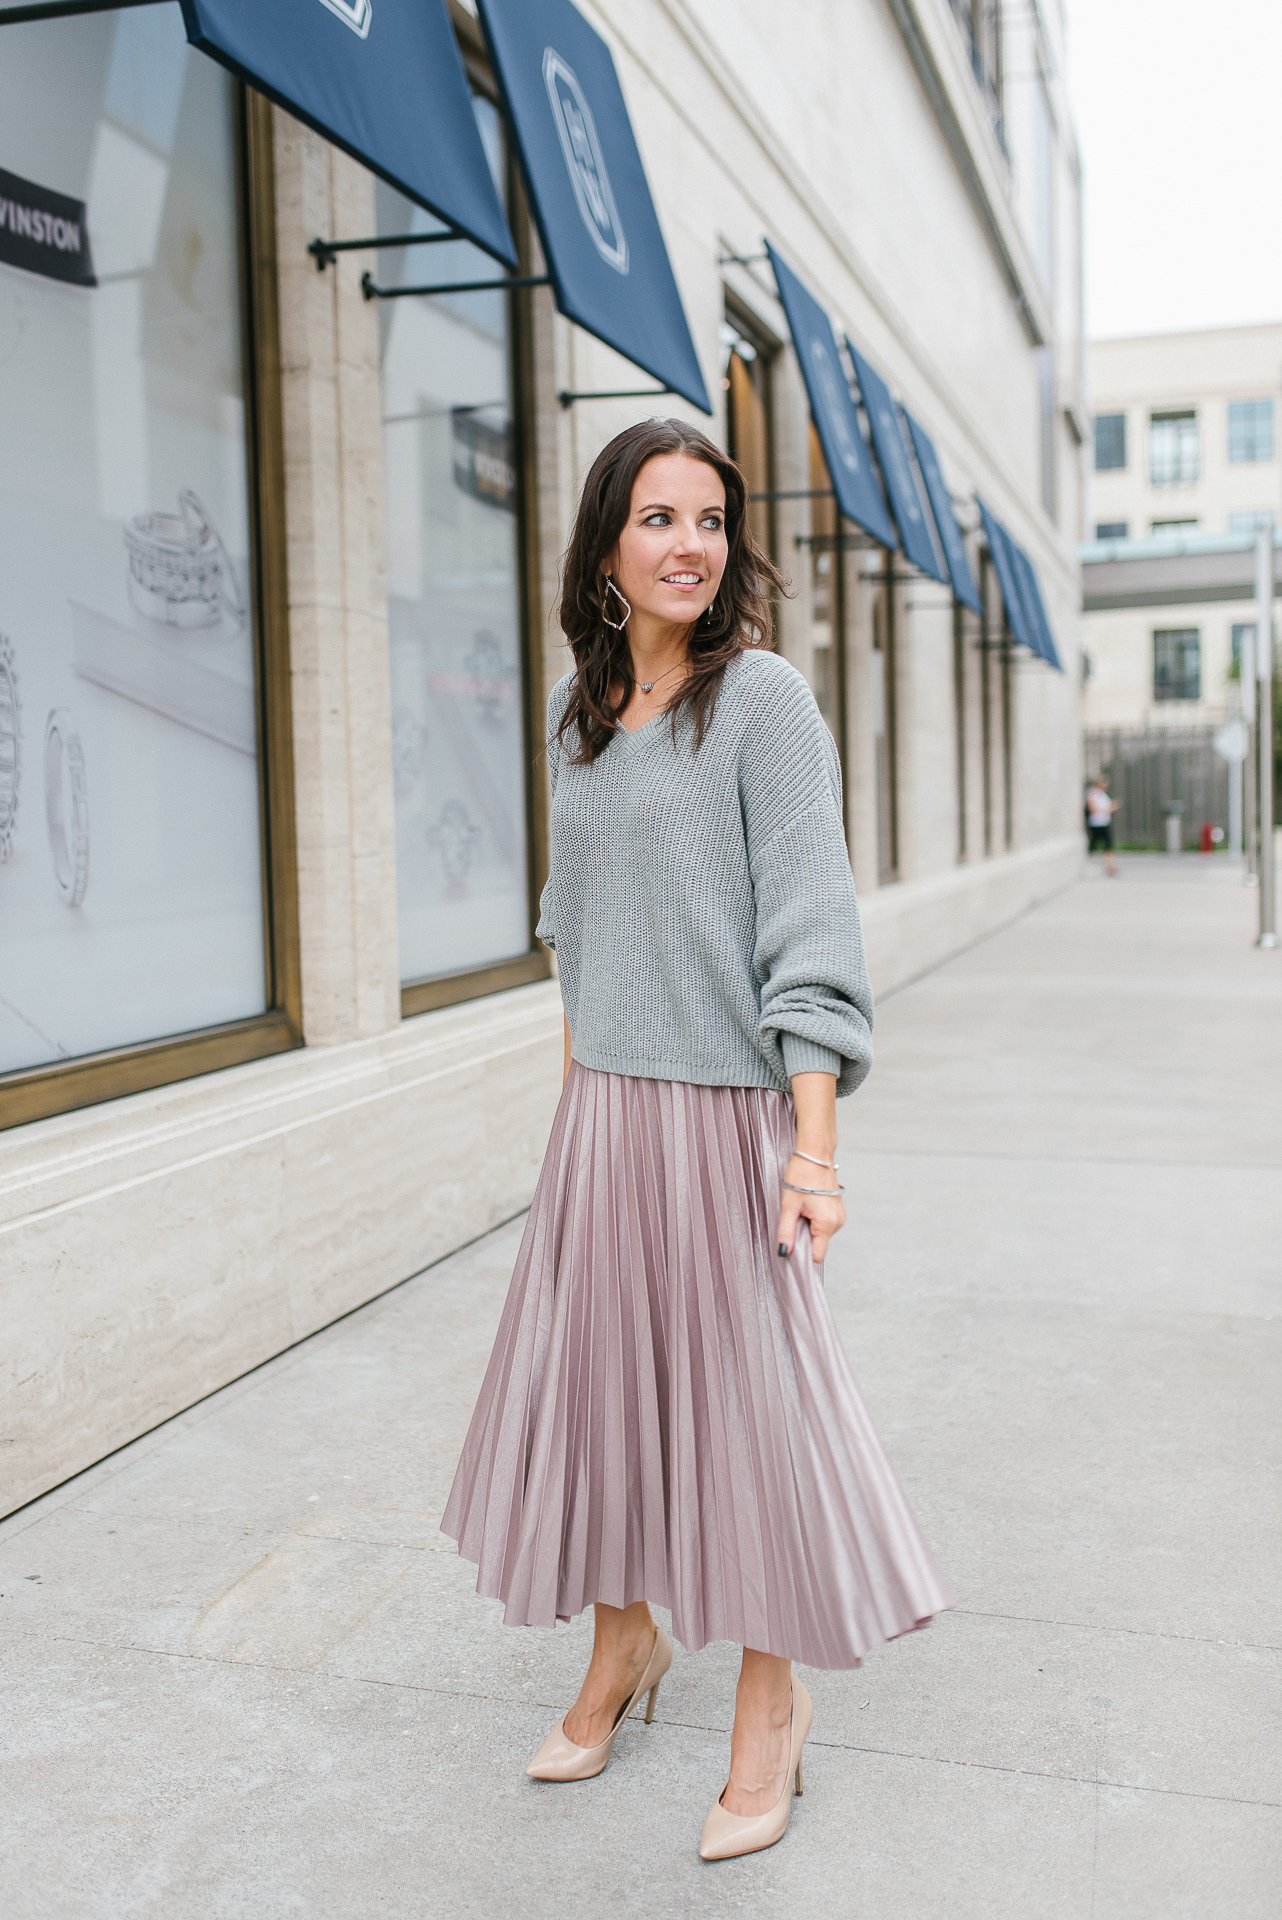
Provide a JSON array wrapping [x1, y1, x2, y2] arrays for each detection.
[[0, 0, 1080, 1511]]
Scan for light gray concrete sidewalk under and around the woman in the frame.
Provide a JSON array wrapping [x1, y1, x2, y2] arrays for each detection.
[[0, 856, 1282, 1920]]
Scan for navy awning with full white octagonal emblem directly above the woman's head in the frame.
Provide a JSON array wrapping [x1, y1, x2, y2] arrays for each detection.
[[475, 0, 712, 413]]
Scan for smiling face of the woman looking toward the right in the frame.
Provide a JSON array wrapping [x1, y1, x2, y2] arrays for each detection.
[[605, 453, 727, 626]]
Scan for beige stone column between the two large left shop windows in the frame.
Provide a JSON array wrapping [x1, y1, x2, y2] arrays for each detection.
[[274, 109, 401, 1046]]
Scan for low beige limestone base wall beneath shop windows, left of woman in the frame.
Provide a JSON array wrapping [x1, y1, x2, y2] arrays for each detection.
[[0, 983, 560, 1513]]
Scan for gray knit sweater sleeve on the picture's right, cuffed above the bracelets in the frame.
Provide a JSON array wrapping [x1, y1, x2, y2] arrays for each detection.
[[739, 662, 873, 1096]]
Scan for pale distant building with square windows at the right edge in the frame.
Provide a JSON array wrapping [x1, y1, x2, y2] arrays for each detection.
[[1082, 323, 1282, 732]]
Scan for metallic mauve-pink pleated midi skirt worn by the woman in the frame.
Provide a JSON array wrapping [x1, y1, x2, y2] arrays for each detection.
[[441, 1064, 952, 1667]]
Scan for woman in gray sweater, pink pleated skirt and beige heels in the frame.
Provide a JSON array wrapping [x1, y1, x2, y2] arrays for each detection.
[[441, 420, 950, 1859]]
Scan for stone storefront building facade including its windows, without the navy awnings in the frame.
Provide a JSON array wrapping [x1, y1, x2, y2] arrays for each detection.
[[0, 0, 1086, 1511]]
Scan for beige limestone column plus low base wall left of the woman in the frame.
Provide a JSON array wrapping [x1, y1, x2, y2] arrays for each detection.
[[0, 113, 560, 1511]]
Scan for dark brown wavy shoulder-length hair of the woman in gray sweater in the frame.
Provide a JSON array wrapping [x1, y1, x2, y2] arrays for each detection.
[[557, 420, 789, 766]]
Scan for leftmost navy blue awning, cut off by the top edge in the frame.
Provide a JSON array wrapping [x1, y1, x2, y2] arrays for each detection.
[[182, 0, 516, 267]]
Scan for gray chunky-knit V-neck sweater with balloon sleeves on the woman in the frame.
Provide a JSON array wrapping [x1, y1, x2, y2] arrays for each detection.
[[537, 649, 873, 1094]]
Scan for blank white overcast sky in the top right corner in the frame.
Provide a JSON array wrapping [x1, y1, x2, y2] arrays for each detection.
[[1067, 0, 1282, 338]]
